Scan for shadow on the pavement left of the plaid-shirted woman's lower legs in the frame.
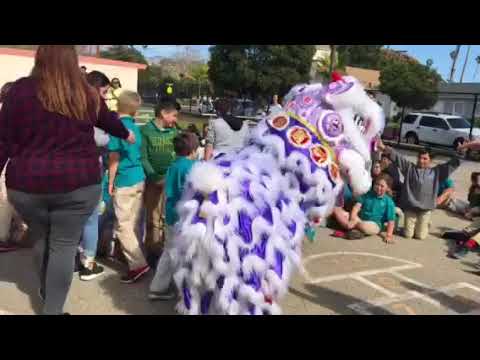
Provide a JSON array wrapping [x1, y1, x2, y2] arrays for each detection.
[[0, 248, 42, 314]]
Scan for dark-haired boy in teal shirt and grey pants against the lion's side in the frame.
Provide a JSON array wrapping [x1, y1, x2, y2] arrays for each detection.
[[148, 132, 198, 300]]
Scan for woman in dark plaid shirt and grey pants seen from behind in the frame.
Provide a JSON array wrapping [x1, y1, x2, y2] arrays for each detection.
[[0, 45, 135, 315]]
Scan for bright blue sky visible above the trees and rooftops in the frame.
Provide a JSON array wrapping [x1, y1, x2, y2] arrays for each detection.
[[144, 45, 480, 82]]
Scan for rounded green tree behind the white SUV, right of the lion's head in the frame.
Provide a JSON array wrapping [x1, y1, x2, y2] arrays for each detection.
[[380, 60, 442, 110]]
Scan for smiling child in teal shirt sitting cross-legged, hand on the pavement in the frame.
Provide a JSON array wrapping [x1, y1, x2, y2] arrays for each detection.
[[337, 174, 395, 243]]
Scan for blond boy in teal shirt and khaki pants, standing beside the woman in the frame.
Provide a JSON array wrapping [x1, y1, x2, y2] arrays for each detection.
[[108, 91, 150, 283]]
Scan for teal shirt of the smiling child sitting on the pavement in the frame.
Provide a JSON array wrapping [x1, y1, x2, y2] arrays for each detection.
[[357, 190, 395, 229]]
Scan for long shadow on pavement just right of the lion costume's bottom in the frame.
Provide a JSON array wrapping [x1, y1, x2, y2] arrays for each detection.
[[289, 284, 393, 315]]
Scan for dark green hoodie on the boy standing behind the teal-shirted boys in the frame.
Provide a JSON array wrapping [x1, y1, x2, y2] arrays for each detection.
[[141, 120, 178, 182]]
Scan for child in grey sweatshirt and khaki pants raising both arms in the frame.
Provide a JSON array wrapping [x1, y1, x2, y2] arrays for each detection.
[[378, 141, 460, 240]]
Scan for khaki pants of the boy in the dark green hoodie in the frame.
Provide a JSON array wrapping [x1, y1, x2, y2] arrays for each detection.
[[145, 182, 165, 255]]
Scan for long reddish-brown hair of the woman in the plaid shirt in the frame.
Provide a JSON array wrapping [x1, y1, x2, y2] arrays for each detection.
[[32, 45, 100, 120]]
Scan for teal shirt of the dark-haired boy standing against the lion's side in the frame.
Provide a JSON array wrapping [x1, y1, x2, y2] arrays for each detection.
[[165, 156, 195, 225]]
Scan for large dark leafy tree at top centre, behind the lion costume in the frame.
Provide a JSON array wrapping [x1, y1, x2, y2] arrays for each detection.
[[208, 45, 315, 100]]
